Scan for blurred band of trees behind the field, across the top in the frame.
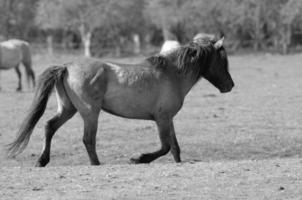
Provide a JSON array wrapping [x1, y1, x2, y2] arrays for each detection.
[[0, 0, 302, 57]]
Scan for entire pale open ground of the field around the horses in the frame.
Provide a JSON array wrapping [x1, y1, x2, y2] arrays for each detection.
[[0, 54, 302, 199]]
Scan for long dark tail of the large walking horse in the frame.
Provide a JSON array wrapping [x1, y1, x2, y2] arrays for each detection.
[[8, 66, 67, 157]]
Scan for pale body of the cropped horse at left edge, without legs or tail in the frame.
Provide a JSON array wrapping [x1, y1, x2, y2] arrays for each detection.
[[0, 39, 28, 69]]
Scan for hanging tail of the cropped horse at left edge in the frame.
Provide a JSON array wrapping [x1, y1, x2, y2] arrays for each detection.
[[21, 42, 36, 87]]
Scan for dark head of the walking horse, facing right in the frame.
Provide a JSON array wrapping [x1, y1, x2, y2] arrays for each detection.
[[194, 37, 234, 93]]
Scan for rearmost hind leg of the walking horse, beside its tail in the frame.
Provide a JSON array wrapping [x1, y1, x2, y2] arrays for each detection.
[[36, 88, 77, 167]]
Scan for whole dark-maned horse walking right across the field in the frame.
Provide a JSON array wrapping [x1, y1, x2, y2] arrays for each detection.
[[8, 34, 234, 167]]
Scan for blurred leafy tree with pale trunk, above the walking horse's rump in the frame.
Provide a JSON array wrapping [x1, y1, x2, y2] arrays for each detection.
[[36, 0, 108, 57]]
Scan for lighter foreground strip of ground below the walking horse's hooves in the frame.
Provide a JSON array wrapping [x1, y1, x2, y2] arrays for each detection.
[[0, 159, 302, 200]]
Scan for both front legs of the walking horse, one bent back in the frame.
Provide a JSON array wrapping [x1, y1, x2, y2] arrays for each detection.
[[130, 119, 180, 164]]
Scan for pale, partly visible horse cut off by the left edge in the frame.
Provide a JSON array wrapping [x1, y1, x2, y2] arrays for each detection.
[[0, 39, 35, 91]]
